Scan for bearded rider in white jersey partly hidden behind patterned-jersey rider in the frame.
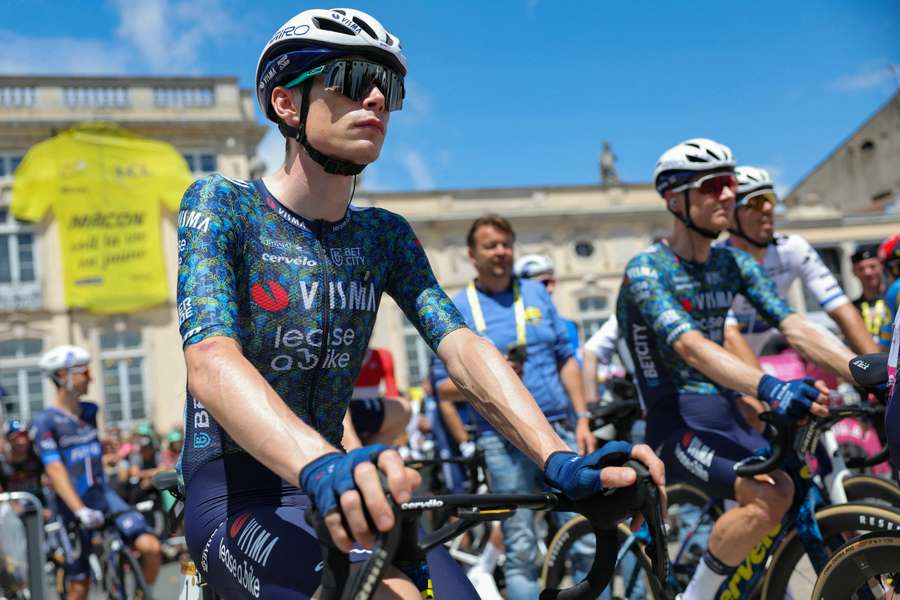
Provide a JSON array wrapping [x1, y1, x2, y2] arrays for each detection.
[[721, 166, 878, 356]]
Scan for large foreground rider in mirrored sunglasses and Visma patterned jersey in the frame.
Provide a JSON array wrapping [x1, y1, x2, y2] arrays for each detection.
[[178, 9, 663, 598]]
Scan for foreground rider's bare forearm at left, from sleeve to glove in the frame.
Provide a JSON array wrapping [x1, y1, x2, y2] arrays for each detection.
[[184, 337, 336, 484]]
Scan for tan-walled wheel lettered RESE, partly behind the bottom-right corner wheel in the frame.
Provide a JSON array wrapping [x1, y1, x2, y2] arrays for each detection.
[[762, 504, 900, 600]]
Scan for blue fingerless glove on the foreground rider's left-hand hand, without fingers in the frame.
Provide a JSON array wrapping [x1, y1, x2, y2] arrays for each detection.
[[300, 444, 387, 515]]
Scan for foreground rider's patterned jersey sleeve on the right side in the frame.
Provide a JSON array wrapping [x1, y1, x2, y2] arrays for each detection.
[[385, 213, 466, 351]]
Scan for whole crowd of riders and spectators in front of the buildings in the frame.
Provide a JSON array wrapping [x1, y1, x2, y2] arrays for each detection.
[[4, 2, 900, 600]]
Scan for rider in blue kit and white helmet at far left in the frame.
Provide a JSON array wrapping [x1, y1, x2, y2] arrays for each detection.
[[33, 346, 160, 599]]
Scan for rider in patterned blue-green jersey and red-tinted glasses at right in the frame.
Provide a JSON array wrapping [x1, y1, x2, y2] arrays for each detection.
[[616, 139, 852, 599]]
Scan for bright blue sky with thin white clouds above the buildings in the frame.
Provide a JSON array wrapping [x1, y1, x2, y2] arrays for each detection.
[[0, 0, 900, 190]]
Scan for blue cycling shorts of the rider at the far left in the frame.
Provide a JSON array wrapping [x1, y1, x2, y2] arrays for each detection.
[[54, 486, 152, 580]]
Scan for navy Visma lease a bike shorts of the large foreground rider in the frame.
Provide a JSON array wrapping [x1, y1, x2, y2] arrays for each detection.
[[184, 453, 478, 600]]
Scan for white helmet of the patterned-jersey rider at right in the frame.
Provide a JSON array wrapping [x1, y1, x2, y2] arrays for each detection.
[[653, 138, 735, 195]]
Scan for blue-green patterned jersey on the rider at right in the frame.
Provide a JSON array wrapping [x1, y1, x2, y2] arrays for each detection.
[[616, 242, 793, 410]]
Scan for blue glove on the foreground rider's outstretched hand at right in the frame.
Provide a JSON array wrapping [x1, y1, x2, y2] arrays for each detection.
[[544, 442, 631, 500]]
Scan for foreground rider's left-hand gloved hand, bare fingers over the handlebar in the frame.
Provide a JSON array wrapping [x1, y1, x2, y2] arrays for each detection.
[[300, 444, 422, 552]]
